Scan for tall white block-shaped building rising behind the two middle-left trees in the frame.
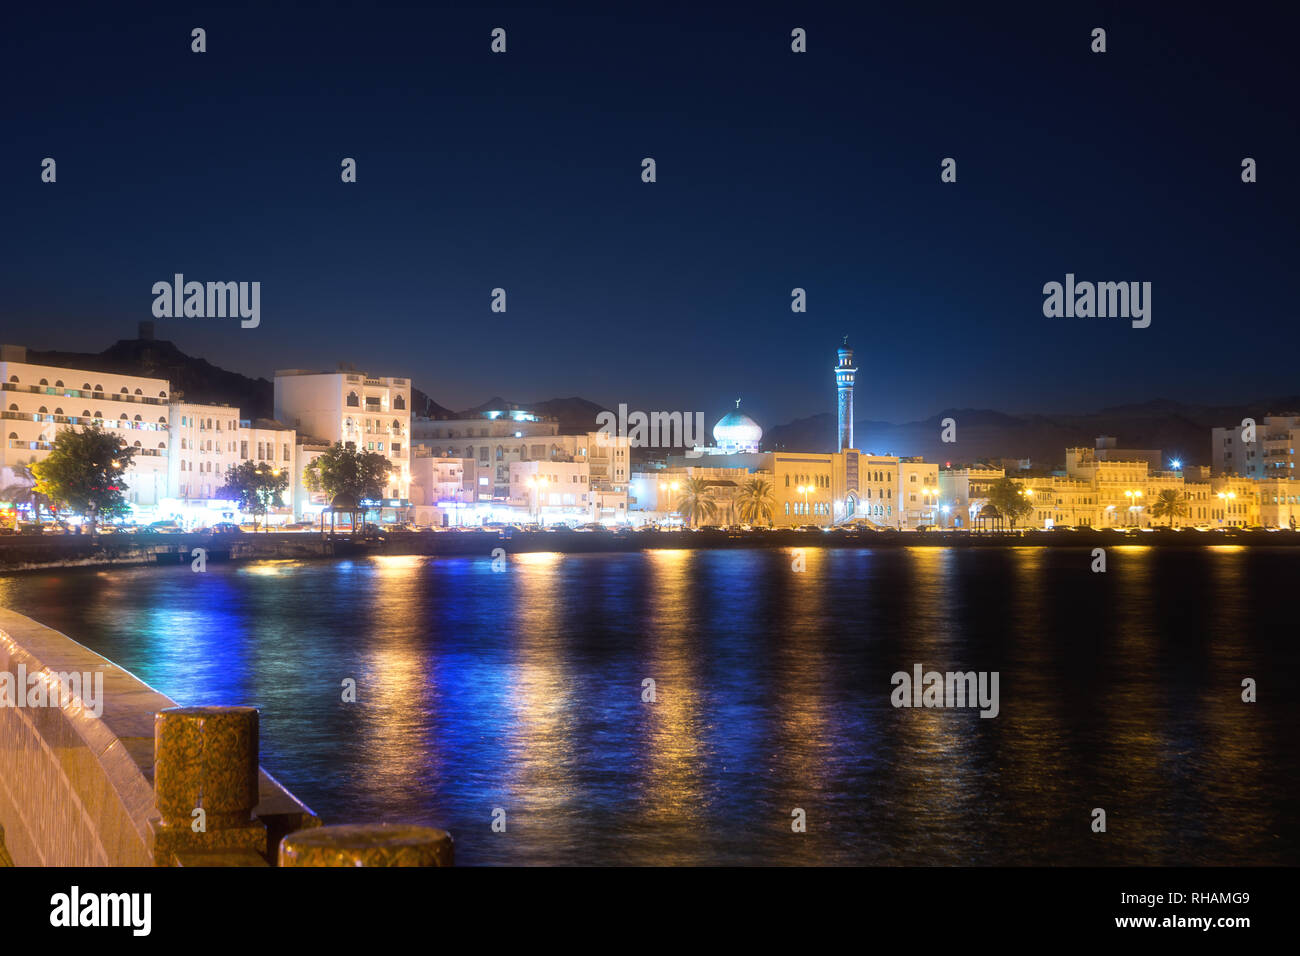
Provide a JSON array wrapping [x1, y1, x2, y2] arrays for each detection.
[[276, 368, 411, 514]]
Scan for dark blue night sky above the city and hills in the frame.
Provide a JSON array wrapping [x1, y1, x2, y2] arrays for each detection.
[[0, 3, 1300, 424]]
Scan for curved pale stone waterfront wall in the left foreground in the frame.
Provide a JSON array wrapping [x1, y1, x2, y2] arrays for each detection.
[[0, 609, 320, 866]]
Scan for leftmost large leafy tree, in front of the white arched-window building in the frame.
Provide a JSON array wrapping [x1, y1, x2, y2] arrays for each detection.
[[31, 424, 137, 535]]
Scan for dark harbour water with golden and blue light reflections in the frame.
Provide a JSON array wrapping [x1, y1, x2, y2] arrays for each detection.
[[0, 546, 1300, 865]]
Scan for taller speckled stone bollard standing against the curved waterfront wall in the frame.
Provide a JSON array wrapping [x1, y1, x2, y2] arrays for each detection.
[[153, 706, 268, 866]]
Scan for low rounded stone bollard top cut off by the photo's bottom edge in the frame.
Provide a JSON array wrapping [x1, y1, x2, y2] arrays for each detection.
[[280, 823, 454, 866]]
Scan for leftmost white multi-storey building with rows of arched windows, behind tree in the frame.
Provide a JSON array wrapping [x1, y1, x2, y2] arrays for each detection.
[[0, 345, 170, 511]]
